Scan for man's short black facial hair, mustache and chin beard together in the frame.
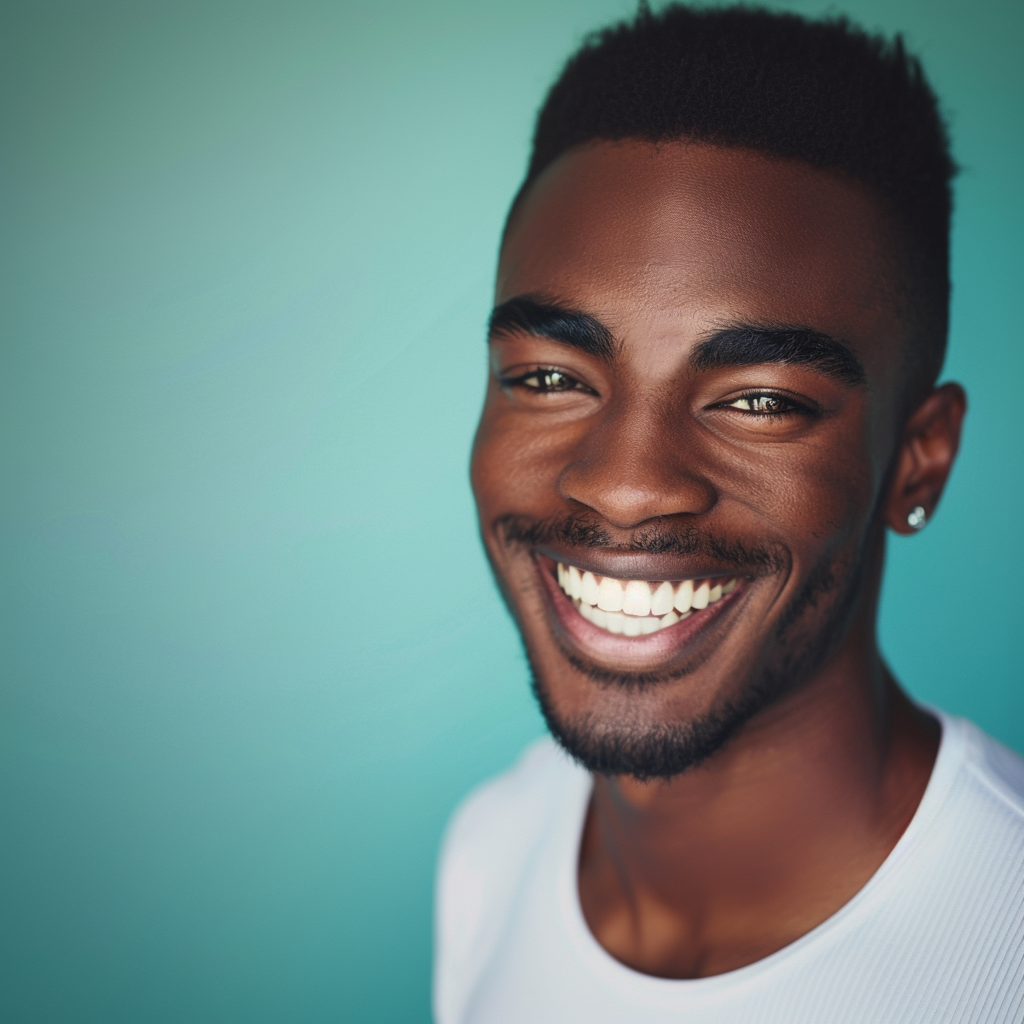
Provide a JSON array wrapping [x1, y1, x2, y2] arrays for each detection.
[[496, 507, 865, 781]]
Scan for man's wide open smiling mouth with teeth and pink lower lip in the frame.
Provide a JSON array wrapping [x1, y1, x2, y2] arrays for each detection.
[[536, 553, 744, 663]]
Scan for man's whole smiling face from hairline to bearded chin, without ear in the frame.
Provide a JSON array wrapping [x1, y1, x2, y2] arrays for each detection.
[[472, 142, 951, 777]]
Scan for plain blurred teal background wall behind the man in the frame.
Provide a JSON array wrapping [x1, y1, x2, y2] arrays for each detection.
[[0, 0, 1024, 1024]]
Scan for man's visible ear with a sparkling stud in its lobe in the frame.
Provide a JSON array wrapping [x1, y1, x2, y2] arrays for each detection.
[[886, 384, 967, 534]]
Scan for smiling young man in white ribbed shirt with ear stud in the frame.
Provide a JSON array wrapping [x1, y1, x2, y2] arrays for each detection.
[[435, 7, 1024, 1024]]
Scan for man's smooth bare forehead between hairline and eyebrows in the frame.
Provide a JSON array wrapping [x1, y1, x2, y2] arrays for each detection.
[[498, 140, 900, 362]]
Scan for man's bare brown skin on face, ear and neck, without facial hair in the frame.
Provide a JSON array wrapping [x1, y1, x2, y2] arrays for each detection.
[[472, 141, 966, 978]]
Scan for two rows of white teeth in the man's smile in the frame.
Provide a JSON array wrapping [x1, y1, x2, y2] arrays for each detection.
[[558, 562, 737, 636]]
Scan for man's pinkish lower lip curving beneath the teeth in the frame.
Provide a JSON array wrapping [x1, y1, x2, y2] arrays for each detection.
[[535, 556, 743, 666]]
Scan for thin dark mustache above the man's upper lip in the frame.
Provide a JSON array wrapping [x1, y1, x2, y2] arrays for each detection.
[[494, 512, 786, 574]]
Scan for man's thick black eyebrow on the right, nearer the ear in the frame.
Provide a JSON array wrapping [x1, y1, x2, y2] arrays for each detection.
[[690, 324, 867, 387]]
